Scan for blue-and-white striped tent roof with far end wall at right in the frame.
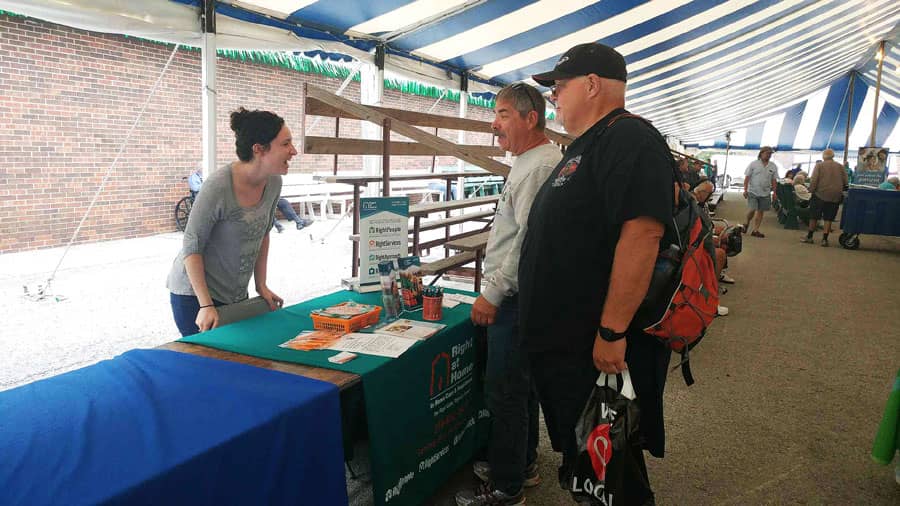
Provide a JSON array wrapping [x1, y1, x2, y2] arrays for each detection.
[[172, 0, 900, 150]]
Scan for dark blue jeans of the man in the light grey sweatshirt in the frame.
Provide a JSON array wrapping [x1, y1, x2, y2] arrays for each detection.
[[485, 296, 538, 494]]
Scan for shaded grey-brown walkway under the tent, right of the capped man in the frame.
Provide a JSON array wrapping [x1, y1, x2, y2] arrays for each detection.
[[435, 193, 900, 506]]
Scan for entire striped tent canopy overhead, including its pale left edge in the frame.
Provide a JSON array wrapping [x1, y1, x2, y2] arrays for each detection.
[[0, 0, 900, 150]]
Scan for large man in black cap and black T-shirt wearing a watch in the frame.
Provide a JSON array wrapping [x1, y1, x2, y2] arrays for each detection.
[[519, 43, 675, 503]]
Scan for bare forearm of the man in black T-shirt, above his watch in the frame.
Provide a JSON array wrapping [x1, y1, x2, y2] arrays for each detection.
[[600, 217, 664, 332]]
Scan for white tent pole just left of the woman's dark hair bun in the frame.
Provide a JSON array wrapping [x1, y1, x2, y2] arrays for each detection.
[[200, 0, 216, 177]]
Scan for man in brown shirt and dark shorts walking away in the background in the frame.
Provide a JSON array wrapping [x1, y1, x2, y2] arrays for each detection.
[[803, 148, 850, 247]]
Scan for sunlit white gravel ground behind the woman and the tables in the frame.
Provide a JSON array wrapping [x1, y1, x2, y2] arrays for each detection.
[[0, 219, 350, 390]]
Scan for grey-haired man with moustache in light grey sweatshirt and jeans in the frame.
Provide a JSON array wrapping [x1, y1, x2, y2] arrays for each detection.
[[456, 83, 562, 506]]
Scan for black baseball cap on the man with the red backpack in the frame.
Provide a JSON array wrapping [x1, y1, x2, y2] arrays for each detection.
[[531, 42, 628, 87]]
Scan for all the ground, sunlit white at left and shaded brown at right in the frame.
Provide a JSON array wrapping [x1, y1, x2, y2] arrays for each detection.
[[0, 193, 900, 506]]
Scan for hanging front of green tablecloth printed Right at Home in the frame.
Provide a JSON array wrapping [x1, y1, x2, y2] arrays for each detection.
[[363, 304, 490, 506]]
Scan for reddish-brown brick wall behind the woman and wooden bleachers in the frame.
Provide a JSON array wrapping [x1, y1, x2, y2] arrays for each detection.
[[0, 15, 493, 253]]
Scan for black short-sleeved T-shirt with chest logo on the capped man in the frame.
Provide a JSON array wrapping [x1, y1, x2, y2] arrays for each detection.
[[519, 109, 675, 351]]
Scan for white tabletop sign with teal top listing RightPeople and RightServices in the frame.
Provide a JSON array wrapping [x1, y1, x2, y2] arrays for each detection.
[[359, 197, 409, 288]]
